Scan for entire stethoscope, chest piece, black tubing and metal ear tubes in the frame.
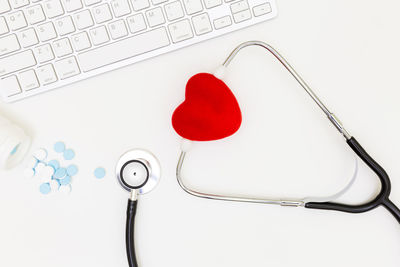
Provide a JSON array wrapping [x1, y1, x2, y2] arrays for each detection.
[[116, 41, 400, 267]]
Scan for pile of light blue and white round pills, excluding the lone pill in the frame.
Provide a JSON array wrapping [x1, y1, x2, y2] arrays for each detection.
[[24, 142, 78, 195]]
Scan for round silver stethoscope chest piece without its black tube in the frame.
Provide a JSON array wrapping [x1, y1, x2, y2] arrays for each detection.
[[115, 149, 161, 194]]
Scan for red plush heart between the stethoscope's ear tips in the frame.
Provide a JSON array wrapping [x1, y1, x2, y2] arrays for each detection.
[[172, 73, 242, 141]]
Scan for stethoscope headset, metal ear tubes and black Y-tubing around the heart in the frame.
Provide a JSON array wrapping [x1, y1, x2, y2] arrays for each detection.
[[176, 41, 400, 223]]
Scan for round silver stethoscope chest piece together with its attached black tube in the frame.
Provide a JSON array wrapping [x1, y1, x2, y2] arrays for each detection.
[[116, 149, 161, 267]]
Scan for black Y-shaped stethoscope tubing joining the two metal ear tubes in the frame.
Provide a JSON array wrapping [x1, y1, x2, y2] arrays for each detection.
[[305, 137, 400, 223]]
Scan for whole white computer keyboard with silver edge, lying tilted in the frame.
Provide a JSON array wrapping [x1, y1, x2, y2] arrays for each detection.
[[0, 0, 277, 102]]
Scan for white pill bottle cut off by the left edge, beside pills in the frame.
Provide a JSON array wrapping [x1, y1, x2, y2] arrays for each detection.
[[0, 114, 31, 170]]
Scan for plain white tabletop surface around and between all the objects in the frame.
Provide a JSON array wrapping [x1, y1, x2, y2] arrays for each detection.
[[0, 0, 400, 267]]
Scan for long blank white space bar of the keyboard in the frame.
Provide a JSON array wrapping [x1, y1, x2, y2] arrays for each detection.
[[78, 27, 170, 72]]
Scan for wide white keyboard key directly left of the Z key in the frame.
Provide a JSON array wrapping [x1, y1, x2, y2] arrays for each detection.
[[0, 50, 36, 76]]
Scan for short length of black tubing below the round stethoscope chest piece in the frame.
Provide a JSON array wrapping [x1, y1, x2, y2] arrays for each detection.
[[125, 199, 138, 267]]
